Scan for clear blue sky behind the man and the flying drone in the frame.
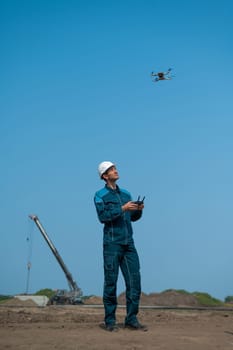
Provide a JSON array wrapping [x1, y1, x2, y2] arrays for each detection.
[[0, 0, 233, 299]]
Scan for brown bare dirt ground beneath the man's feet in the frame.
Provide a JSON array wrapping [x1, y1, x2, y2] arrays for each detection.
[[0, 301, 233, 350]]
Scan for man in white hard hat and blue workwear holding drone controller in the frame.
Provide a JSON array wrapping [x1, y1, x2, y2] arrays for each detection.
[[94, 161, 147, 331]]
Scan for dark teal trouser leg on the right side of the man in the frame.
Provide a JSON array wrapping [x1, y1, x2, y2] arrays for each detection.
[[121, 245, 141, 324]]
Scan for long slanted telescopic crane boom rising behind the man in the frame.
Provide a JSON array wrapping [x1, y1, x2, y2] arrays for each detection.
[[29, 215, 82, 299]]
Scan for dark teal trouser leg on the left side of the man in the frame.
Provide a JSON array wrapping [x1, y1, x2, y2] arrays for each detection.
[[103, 245, 119, 325]]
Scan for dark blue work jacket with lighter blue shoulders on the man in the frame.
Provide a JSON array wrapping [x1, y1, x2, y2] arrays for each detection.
[[94, 185, 142, 244]]
